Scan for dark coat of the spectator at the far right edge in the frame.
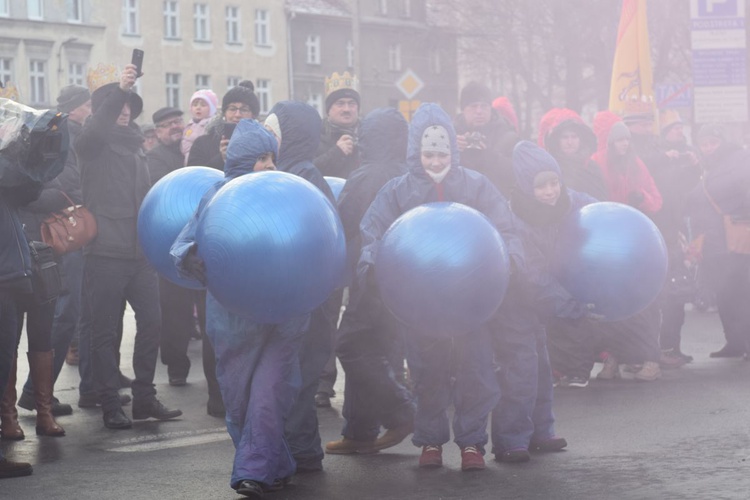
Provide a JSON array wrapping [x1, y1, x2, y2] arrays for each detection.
[[687, 144, 750, 257]]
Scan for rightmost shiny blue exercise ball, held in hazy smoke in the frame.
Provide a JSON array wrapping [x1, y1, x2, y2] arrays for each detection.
[[551, 202, 667, 321]]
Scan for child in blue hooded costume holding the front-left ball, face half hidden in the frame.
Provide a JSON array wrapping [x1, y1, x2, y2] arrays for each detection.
[[171, 120, 300, 498]]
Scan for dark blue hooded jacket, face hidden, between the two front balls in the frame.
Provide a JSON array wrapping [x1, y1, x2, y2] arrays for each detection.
[[338, 108, 409, 273]]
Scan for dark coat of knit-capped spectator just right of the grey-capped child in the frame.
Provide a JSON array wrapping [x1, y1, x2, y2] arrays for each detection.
[[455, 110, 519, 198]]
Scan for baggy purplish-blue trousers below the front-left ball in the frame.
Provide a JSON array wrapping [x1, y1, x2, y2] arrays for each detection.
[[206, 293, 310, 488]]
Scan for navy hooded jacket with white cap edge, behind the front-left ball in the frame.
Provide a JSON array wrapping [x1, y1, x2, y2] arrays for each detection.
[[268, 101, 336, 203]]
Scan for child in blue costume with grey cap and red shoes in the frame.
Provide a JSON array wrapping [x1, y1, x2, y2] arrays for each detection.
[[357, 104, 524, 470]]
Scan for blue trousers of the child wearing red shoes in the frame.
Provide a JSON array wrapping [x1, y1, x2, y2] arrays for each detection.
[[407, 329, 499, 451]]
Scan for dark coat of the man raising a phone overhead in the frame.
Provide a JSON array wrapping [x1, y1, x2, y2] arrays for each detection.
[[75, 87, 151, 259]]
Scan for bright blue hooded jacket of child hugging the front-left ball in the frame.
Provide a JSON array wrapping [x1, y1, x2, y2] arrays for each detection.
[[169, 119, 279, 279]]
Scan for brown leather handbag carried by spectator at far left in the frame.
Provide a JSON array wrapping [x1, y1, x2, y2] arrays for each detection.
[[40, 193, 96, 255]]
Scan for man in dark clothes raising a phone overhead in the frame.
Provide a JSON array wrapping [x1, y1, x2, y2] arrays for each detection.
[[75, 64, 182, 429]]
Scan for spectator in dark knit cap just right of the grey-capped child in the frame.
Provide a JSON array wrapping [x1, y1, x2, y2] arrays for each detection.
[[454, 82, 518, 198]]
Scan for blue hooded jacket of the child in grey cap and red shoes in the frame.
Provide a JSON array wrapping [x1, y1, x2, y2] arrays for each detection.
[[357, 103, 525, 279]]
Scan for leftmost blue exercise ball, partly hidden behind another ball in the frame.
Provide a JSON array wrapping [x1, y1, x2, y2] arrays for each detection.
[[138, 167, 224, 289]]
